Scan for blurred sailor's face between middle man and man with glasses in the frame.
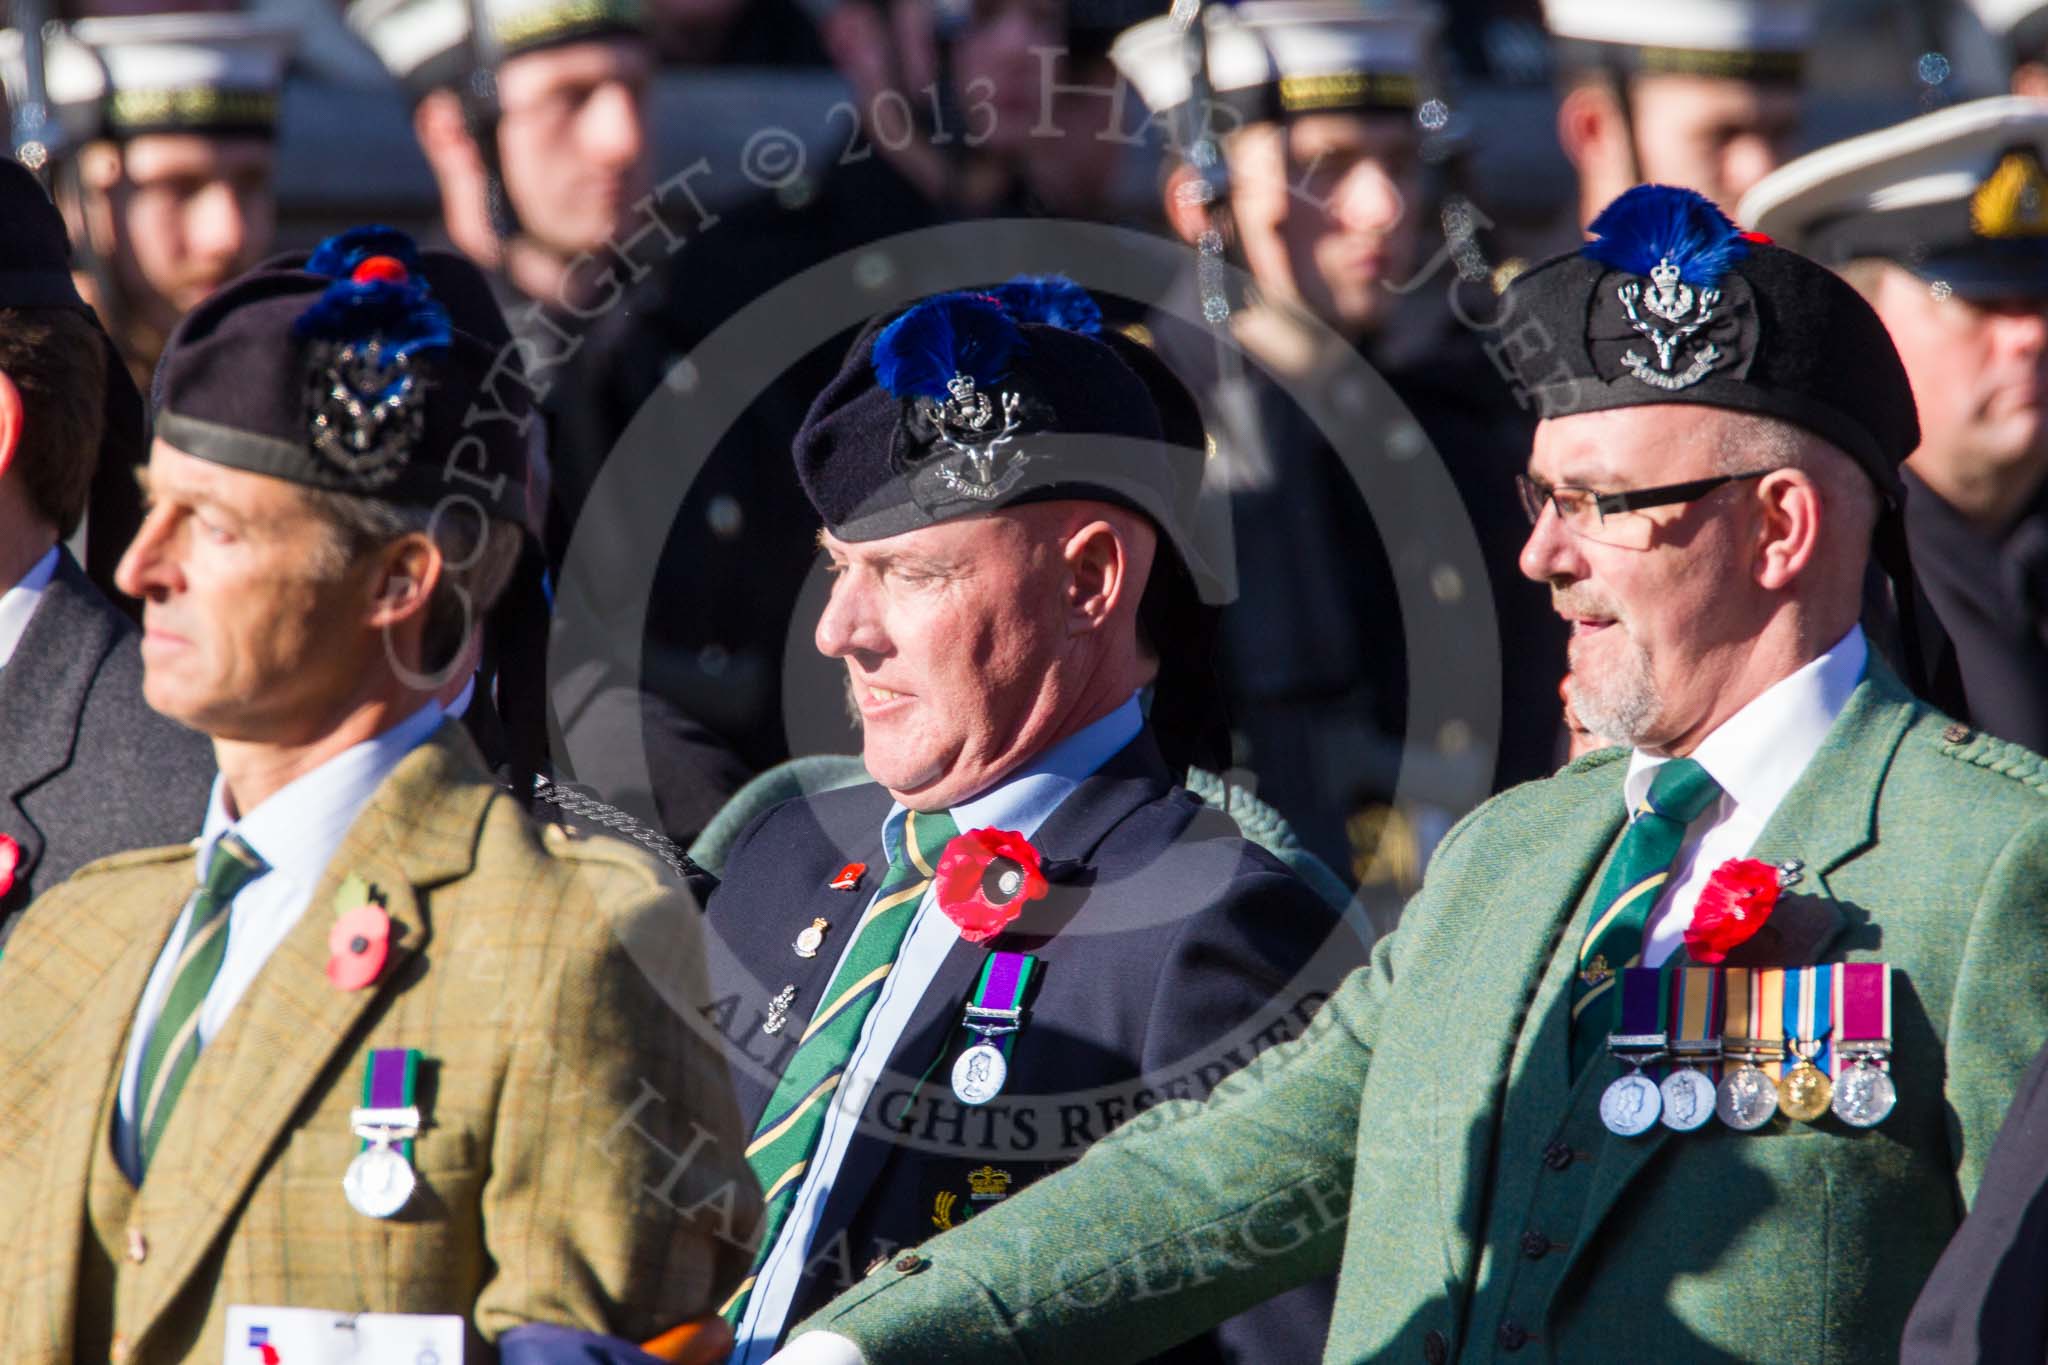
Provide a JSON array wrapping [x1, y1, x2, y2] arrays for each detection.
[[1227, 113, 1421, 338]]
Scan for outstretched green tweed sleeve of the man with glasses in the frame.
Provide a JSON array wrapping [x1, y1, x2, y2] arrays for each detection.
[[778, 916, 1401, 1365]]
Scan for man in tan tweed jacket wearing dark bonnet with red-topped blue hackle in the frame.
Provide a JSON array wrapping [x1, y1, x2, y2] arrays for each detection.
[[0, 229, 758, 1365]]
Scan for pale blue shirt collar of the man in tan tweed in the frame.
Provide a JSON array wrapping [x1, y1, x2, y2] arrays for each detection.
[[199, 702, 442, 888]]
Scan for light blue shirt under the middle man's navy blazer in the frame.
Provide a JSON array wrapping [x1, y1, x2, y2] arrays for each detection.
[[729, 694, 1145, 1365]]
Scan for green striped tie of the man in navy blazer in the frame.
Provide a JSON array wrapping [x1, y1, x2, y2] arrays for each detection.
[[719, 810, 961, 1326]]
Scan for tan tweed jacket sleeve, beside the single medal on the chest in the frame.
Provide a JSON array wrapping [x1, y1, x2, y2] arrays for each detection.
[[475, 851, 760, 1340]]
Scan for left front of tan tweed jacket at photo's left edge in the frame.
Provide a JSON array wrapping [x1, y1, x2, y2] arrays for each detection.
[[0, 849, 197, 1359]]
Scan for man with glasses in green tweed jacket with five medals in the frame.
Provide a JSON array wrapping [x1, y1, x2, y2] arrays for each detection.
[[761, 186, 2048, 1365]]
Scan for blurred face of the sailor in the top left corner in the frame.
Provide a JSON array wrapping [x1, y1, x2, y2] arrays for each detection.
[[82, 133, 276, 343]]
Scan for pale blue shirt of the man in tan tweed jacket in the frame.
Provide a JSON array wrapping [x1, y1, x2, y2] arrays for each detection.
[[115, 702, 440, 1181]]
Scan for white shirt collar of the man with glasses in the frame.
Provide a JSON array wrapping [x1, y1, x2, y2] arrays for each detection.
[[1622, 626, 1870, 812]]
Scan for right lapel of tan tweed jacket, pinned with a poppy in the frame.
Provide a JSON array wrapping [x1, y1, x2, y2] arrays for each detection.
[[125, 720, 496, 1324]]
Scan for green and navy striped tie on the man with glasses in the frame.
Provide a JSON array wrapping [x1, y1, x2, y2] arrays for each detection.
[[1571, 759, 1720, 1076]]
